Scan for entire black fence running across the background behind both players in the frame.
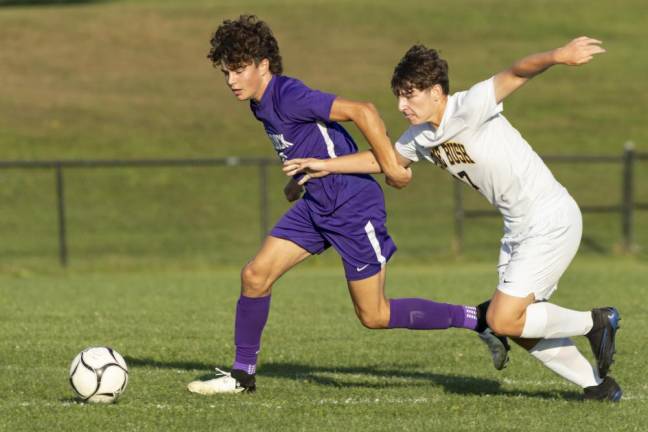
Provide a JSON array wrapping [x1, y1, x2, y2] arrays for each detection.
[[0, 143, 648, 266]]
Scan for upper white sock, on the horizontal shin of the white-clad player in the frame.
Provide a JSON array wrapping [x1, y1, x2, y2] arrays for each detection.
[[520, 302, 593, 339]]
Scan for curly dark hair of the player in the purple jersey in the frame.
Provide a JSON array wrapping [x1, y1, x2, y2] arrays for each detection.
[[207, 15, 283, 75]]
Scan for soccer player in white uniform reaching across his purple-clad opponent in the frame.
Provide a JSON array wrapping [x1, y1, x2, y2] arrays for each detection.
[[284, 37, 622, 401]]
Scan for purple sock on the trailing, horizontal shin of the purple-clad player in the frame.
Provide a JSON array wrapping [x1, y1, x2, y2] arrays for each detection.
[[389, 299, 477, 330]]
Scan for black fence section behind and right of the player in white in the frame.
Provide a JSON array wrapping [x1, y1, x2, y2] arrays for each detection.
[[453, 142, 648, 254]]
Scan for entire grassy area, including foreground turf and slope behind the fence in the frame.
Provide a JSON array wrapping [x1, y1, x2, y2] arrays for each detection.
[[0, 0, 648, 432]]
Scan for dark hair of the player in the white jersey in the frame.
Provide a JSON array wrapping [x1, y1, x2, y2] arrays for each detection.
[[391, 45, 450, 96]]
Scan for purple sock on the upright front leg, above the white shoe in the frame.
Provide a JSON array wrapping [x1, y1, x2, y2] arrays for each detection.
[[232, 295, 270, 374]]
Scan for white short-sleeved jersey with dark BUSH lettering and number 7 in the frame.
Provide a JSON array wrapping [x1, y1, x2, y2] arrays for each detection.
[[396, 78, 566, 237]]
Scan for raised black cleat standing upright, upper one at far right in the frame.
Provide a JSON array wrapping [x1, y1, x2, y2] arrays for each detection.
[[585, 307, 621, 378]]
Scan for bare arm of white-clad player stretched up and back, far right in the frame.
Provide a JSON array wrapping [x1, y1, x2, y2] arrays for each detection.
[[494, 36, 605, 103]]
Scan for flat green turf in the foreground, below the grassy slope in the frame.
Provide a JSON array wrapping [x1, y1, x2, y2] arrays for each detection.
[[0, 259, 648, 431]]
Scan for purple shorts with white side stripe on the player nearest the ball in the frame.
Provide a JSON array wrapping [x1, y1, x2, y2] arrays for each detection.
[[270, 184, 396, 281]]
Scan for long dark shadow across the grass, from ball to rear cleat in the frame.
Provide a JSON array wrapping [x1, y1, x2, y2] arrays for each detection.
[[125, 356, 582, 400]]
